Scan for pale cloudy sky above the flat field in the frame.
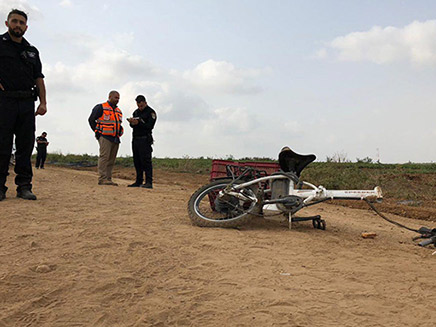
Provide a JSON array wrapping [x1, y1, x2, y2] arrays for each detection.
[[0, 0, 436, 163]]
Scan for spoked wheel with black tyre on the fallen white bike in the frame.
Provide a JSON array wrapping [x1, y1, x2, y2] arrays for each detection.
[[188, 179, 256, 228]]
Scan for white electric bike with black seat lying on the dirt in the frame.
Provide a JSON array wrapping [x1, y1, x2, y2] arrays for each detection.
[[188, 147, 436, 246]]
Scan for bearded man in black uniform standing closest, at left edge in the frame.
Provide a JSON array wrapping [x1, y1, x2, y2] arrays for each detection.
[[0, 9, 47, 201]]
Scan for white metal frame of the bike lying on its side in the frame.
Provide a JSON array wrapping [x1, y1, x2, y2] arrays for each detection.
[[220, 174, 383, 229]]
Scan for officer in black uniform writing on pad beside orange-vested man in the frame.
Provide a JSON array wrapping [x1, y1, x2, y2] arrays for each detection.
[[127, 95, 157, 188]]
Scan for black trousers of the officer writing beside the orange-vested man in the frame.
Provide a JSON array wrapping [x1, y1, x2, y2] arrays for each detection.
[[132, 136, 153, 184]]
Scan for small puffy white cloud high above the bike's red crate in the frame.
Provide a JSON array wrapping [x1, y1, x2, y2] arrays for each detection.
[[183, 59, 267, 94]]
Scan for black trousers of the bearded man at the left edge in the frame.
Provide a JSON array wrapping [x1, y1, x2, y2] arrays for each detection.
[[0, 97, 35, 192]]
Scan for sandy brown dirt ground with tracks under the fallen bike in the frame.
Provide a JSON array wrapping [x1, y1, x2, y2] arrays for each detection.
[[0, 167, 436, 327]]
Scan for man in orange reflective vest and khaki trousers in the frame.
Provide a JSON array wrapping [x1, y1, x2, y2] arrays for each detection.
[[88, 91, 123, 186]]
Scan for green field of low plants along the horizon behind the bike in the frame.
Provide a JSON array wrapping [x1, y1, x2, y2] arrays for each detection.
[[38, 154, 436, 201]]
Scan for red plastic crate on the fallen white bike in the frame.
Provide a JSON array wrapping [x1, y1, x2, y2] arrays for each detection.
[[210, 160, 280, 180]]
